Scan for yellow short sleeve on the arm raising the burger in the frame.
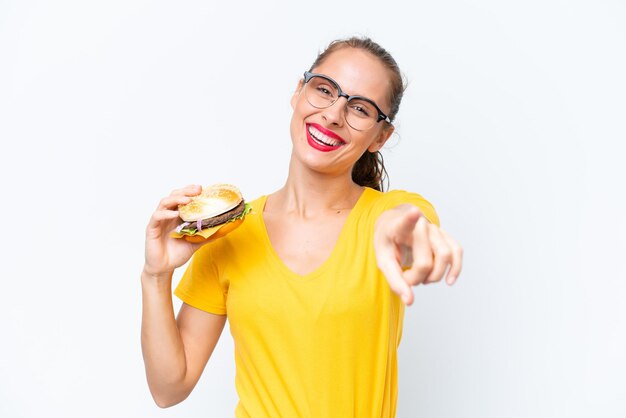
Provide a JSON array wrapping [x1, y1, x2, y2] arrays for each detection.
[[174, 244, 227, 315]]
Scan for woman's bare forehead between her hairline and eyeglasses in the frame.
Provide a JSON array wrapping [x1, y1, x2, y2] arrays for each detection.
[[313, 48, 390, 107]]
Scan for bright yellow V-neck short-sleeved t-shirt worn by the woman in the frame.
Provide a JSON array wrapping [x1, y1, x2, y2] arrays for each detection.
[[175, 188, 439, 418]]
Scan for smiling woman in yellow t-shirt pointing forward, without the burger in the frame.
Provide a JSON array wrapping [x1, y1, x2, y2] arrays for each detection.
[[142, 38, 462, 417]]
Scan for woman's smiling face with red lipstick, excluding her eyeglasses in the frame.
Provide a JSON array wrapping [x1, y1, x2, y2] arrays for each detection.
[[291, 47, 393, 180]]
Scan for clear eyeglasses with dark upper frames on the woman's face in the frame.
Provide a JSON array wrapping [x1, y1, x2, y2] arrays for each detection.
[[304, 71, 391, 131]]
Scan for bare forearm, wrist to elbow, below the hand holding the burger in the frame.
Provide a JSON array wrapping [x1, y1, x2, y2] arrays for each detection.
[[141, 272, 188, 407]]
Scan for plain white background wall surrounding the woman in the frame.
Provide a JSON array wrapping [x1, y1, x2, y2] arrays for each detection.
[[0, 0, 626, 418]]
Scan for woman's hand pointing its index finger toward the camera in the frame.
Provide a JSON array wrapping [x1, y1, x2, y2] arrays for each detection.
[[374, 204, 463, 305]]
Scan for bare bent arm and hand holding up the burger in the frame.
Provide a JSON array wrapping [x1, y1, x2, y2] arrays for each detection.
[[141, 186, 226, 408]]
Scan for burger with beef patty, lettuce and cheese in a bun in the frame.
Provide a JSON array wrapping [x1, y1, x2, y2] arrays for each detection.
[[170, 184, 250, 242]]
